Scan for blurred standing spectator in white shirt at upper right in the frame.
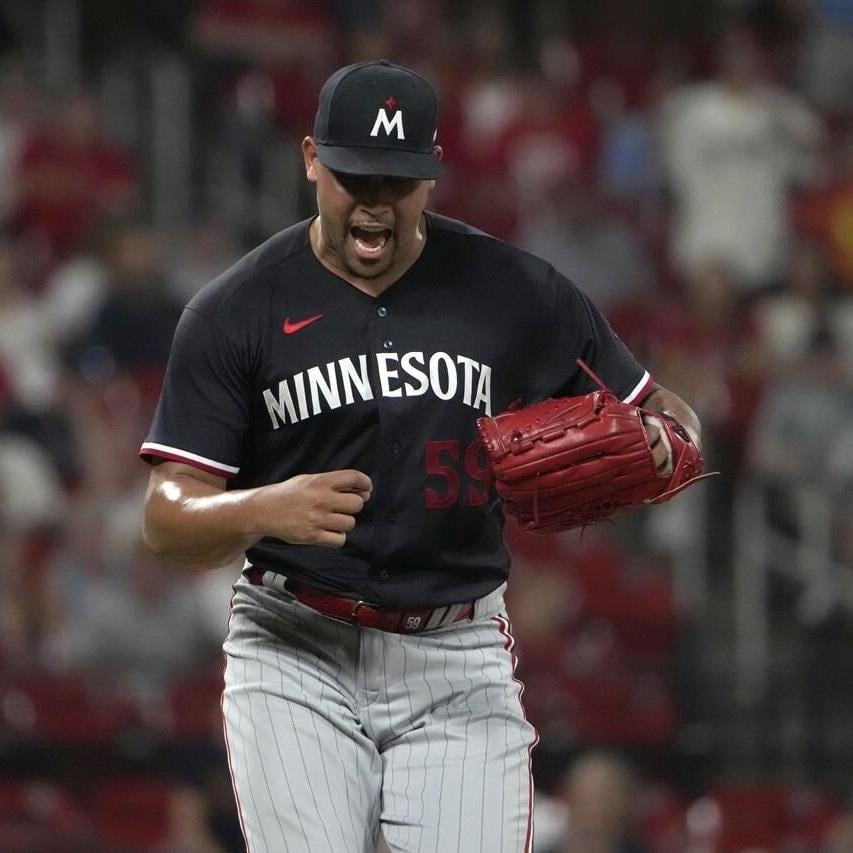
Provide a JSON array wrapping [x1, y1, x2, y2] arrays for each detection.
[[662, 31, 822, 293]]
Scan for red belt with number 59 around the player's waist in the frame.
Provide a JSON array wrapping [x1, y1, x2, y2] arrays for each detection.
[[243, 566, 474, 634]]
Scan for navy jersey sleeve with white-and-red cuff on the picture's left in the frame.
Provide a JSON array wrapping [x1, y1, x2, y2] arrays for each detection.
[[139, 307, 249, 478]]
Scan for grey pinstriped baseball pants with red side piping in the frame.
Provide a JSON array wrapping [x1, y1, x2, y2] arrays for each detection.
[[223, 580, 535, 853]]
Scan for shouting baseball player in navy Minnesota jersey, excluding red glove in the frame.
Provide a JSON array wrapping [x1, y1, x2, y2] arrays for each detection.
[[140, 60, 699, 853]]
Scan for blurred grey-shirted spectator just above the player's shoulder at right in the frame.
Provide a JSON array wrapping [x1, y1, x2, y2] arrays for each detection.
[[517, 178, 654, 313]]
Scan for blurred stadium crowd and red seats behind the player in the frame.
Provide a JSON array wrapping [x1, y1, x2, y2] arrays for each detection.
[[0, 0, 853, 853]]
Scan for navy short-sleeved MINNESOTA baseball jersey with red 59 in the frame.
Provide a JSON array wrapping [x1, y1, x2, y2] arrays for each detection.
[[141, 213, 652, 608]]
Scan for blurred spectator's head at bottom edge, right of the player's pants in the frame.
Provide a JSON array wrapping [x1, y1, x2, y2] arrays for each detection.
[[537, 752, 648, 853]]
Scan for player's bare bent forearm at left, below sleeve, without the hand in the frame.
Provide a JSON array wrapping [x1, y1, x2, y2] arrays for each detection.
[[143, 476, 260, 568]]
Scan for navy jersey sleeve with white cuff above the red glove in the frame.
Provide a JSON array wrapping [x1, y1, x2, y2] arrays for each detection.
[[552, 271, 654, 403]]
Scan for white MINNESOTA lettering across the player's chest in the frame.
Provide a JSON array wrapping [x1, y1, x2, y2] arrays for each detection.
[[263, 352, 492, 429]]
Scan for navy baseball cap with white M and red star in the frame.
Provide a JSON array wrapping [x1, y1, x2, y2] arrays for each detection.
[[314, 59, 441, 180]]
